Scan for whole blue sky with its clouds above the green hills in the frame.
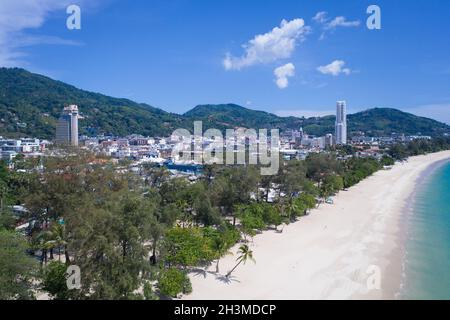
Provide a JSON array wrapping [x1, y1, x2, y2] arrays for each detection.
[[0, 0, 450, 123]]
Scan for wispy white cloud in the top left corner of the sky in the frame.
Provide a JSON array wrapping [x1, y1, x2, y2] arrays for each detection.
[[0, 0, 84, 67]]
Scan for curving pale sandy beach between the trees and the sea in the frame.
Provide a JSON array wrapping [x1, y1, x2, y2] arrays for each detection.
[[184, 151, 450, 300]]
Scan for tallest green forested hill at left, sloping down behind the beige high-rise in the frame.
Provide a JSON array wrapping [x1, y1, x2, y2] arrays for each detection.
[[0, 68, 184, 138]]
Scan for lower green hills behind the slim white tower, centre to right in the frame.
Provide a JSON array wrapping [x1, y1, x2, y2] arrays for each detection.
[[184, 104, 450, 136]]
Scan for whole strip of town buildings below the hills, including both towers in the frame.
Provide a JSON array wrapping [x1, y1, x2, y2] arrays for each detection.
[[0, 101, 431, 165]]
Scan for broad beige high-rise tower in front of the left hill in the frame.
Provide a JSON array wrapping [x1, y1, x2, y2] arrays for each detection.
[[56, 105, 80, 146]]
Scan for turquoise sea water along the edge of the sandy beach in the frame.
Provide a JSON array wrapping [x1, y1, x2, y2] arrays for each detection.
[[400, 161, 450, 300]]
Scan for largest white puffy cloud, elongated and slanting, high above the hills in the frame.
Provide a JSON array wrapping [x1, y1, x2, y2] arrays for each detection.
[[223, 19, 310, 70]]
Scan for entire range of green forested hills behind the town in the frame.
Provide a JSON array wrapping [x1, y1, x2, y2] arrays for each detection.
[[0, 68, 450, 138]]
